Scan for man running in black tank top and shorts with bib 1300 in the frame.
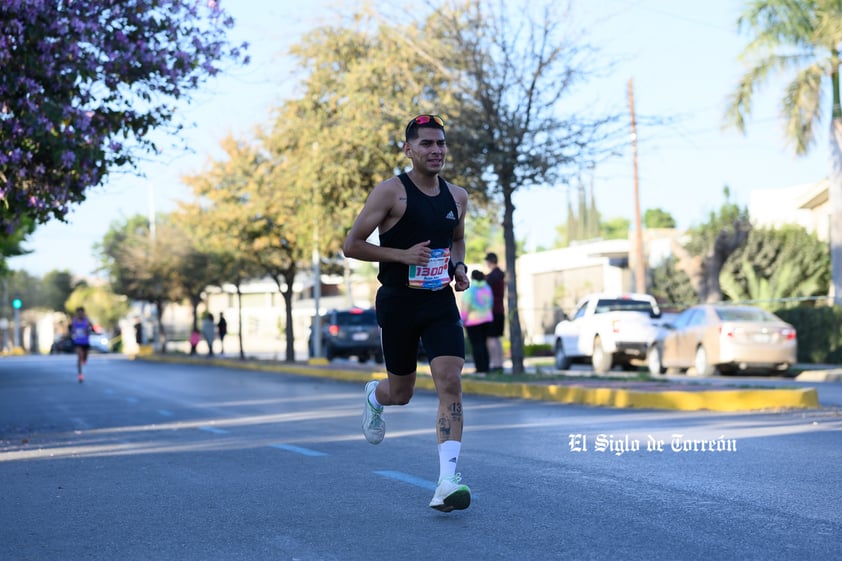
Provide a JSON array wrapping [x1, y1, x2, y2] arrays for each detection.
[[343, 111, 471, 512]]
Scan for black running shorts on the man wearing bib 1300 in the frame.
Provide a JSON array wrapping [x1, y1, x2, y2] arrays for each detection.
[[375, 286, 465, 376]]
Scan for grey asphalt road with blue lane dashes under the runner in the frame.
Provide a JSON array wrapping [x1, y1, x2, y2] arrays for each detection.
[[0, 355, 842, 561]]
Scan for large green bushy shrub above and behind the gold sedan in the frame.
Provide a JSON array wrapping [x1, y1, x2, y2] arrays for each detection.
[[720, 226, 830, 310]]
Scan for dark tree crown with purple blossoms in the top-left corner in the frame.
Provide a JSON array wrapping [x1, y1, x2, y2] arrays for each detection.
[[0, 0, 248, 232]]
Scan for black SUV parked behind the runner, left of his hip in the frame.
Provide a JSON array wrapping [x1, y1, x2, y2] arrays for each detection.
[[309, 308, 383, 363]]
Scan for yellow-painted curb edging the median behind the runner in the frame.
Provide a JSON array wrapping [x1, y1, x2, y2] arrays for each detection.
[[137, 355, 819, 412]]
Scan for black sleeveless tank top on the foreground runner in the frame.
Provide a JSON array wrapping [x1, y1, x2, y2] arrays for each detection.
[[377, 173, 459, 286]]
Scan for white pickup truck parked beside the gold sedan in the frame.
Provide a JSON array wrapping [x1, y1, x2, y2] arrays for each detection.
[[553, 294, 661, 374]]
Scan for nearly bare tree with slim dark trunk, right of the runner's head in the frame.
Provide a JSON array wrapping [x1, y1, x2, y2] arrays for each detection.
[[428, 0, 615, 375]]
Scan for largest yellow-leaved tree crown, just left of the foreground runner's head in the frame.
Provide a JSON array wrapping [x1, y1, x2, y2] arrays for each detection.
[[284, 11, 452, 217]]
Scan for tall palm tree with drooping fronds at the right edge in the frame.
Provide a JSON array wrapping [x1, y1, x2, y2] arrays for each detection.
[[726, 0, 842, 301]]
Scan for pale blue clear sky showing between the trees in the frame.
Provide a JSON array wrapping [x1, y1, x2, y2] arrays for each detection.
[[9, 0, 830, 277]]
